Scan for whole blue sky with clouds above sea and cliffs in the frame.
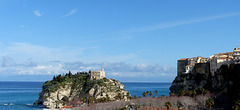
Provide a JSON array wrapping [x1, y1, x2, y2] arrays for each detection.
[[0, 0, 240, 82]]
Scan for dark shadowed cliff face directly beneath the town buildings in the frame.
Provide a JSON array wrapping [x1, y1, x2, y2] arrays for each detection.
[[170, 64, 240, 98]]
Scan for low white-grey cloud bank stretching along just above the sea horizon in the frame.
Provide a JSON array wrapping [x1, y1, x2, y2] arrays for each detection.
[[0, 56, 176, 81]]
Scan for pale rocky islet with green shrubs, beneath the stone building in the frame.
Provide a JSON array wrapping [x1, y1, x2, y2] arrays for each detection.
[[35, 73, 129, 109]]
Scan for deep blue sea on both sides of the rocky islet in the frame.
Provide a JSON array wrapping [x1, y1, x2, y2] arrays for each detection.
[[0, 82, 171, 110]]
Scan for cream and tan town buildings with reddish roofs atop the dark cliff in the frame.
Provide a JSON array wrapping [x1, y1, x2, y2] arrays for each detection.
[[177, 47, 240, 75]]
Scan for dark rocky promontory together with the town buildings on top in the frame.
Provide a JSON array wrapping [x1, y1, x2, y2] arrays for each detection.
[[169, 48, 240, 109]]
